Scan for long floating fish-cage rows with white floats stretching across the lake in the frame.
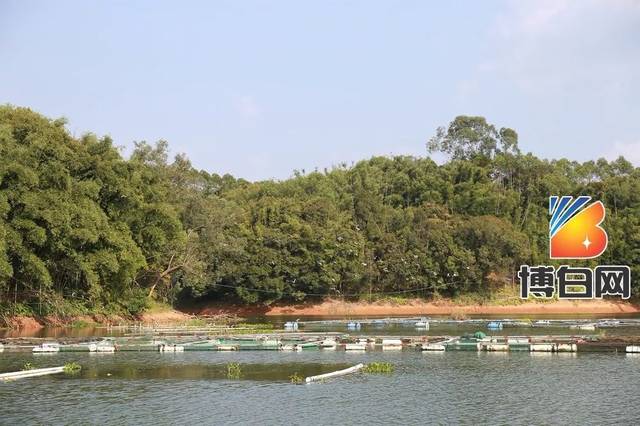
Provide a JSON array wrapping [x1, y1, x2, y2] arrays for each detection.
[[5, 324, 640, 354]]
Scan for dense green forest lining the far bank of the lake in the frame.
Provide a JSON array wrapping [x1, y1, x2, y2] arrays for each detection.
[[0, 105, 640, 315]]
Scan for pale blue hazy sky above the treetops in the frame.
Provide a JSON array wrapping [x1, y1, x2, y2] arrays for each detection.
[[0, 0, 640, 180]]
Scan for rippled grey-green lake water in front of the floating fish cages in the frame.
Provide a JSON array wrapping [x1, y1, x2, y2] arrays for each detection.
[[0, 351, 640, 425]]
